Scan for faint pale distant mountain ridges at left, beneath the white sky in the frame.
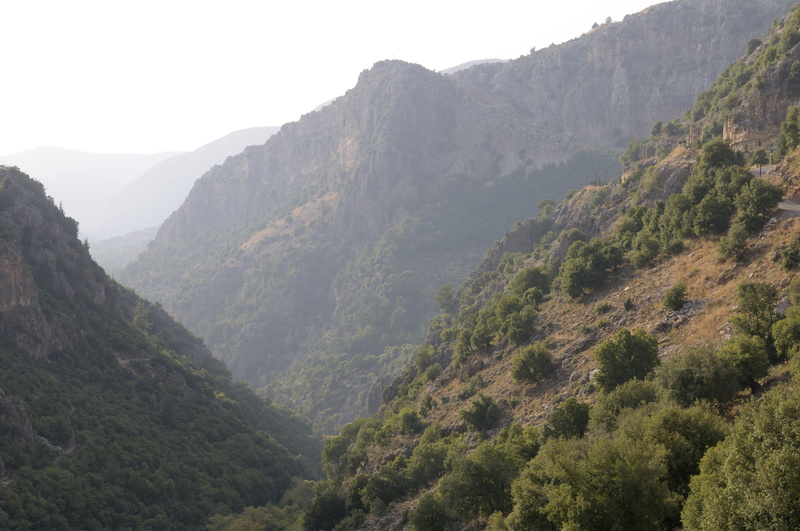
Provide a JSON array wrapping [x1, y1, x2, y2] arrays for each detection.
[[0, 127, 278, 242]]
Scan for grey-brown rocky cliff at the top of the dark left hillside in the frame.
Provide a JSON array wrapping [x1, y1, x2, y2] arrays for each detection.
[[0, 167, 109, 357]]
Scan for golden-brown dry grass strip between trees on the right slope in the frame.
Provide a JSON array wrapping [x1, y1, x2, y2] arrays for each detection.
[[416, 208, 800, 436]]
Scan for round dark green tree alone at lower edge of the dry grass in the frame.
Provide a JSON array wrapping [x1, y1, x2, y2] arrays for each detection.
[[594, 328, 658, 391]]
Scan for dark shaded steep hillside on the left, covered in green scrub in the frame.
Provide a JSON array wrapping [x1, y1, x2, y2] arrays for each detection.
[[0, 167, 320, 529]]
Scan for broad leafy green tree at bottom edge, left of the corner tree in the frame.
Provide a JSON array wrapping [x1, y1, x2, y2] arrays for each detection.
[[506, 437, 676, 531]]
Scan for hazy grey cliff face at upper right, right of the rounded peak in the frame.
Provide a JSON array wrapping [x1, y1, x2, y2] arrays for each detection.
[[454, 0, 793, 150]]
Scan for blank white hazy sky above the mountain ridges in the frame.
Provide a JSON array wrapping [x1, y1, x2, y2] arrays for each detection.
[[0, 0, 659, 155]]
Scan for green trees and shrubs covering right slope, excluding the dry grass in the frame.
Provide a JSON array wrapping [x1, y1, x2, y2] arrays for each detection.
[[296, 15, 800, 531]]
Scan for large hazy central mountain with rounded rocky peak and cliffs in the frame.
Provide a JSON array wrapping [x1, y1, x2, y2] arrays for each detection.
[[120, 0, 790, 431]]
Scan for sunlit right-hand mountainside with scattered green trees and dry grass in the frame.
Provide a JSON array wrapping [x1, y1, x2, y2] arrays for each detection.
[[294, 4, 800, 531]]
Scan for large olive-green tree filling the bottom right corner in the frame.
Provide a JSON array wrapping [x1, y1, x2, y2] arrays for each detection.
[[682, 386, 800, 531]]
